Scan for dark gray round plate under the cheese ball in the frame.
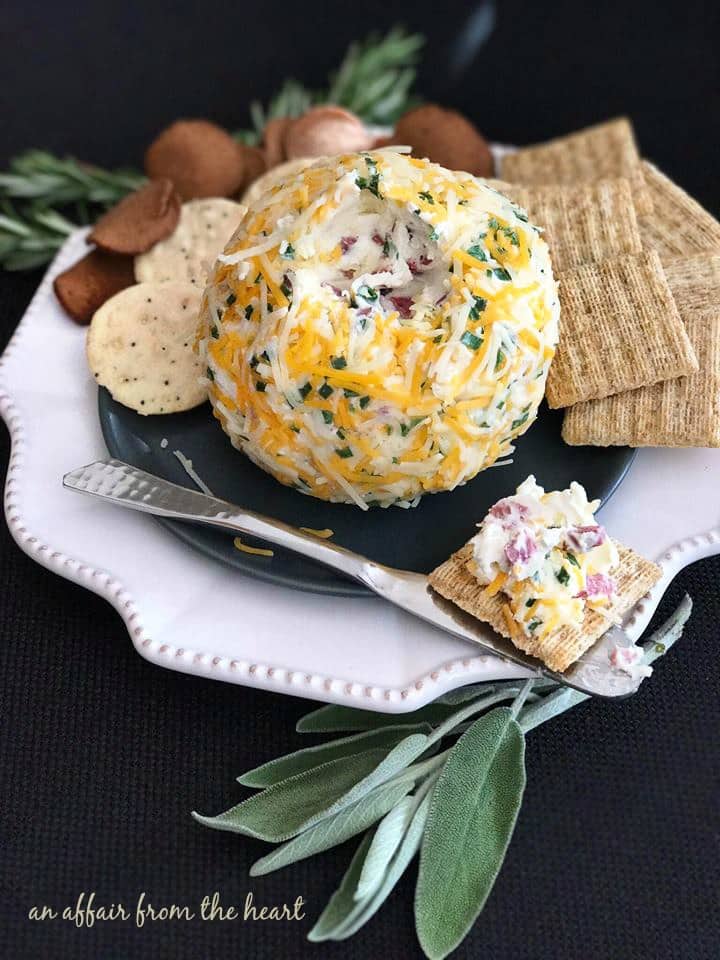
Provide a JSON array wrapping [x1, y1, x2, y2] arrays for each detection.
[[99, 388, 635, 596]]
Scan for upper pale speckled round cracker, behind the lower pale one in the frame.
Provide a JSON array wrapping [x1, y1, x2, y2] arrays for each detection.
[[135, 197, 246, 289]]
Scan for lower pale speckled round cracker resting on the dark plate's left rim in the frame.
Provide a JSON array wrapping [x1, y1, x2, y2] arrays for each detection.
[[87, 282, 207, 414]]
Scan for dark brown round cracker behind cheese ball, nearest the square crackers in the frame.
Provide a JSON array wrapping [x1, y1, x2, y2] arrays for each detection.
[[393, 103, 494, 177]]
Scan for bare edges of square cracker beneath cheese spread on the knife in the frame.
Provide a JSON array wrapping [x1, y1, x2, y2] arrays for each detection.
[[429, 542, 660, 673]]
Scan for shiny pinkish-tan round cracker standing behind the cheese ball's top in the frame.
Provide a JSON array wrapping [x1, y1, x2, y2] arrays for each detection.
[[283, 105, 373, 160]]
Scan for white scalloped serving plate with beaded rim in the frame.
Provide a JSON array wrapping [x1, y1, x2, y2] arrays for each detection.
[[0, 232, 720, 712]]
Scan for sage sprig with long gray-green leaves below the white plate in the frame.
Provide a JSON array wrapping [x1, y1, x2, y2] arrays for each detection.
[[193, 596, 692, 960]]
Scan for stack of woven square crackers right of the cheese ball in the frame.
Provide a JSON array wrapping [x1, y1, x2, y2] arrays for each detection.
[[491, 119, 720, 447]]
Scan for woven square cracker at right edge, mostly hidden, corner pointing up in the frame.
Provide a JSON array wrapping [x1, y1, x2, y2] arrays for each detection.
[[640, 161, 720, 264]]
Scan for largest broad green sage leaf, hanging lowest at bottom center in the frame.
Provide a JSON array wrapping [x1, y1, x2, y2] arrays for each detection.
[[415, 707, 525, 960]]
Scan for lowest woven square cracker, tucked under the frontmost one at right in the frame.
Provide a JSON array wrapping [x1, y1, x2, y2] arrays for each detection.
[[563, 253, 720, 447]]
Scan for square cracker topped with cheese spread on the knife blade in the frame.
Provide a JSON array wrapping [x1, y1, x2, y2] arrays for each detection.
[[430, 476, 660, 672]]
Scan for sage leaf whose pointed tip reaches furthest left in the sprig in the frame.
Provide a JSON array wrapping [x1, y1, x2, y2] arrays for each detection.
[[193, 748, 390, 843]]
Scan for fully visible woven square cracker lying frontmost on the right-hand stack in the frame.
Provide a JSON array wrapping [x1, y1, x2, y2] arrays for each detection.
[[547, 251, 698, 407]]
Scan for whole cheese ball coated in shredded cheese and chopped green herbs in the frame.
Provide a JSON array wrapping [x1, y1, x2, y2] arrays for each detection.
[[199, 150, 559, 509]]
